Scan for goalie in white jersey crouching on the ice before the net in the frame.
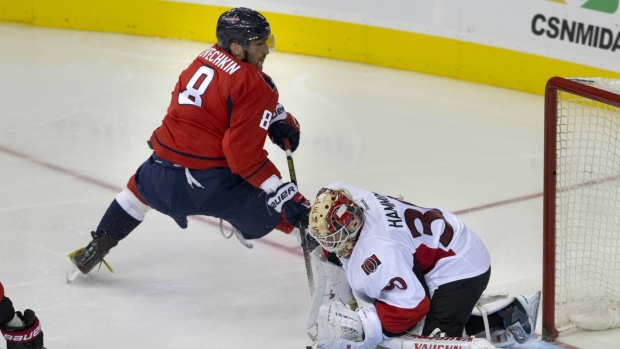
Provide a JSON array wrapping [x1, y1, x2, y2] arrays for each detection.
[[309, 182, 540, 349]]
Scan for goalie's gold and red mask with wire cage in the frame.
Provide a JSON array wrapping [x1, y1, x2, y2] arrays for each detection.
[[308, 188, 364, 258]]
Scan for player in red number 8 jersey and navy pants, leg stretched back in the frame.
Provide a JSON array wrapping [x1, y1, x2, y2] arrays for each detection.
[[69, 8, 310, 274]]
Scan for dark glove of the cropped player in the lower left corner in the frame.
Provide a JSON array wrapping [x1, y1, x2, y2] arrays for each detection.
[[0, 309, 45, 349]]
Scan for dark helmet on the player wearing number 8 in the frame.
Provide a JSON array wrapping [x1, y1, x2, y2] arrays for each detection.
[[215, 7, 275, 51]]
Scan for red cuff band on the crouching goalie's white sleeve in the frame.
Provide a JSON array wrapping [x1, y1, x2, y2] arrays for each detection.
[[375, 297, 431, 333]]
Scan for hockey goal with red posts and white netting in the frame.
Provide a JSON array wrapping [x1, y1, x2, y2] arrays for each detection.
[[542, 77, 620, 340]]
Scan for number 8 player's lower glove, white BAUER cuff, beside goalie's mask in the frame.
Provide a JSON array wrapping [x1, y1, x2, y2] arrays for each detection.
[[267, 182, 310, 227]]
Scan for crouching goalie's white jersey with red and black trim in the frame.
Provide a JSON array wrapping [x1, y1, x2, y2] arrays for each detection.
[[327, 182, 491, 332]]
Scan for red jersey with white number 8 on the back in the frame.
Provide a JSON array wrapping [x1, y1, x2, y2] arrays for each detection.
[[151, 45, 281, 187]]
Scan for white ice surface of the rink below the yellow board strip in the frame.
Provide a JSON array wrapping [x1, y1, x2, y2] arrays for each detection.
[[0, 23, 620, 349]]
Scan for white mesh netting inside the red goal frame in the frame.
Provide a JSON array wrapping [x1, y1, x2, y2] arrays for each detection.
[[555, 78, 620, 331]]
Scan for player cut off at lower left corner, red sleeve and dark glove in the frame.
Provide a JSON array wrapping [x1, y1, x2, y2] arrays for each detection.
[[0, 282, 45, 349]]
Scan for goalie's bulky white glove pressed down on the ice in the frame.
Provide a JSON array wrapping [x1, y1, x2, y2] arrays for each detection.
[[317, 301, 383, 349]]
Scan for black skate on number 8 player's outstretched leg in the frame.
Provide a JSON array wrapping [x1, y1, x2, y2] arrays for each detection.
[[67, 232, 118, 282]]
